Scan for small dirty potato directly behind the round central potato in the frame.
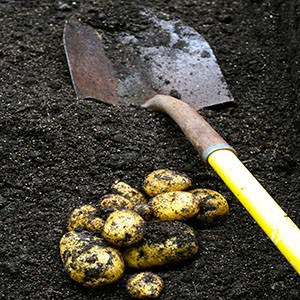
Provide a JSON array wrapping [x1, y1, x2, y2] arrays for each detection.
[[100, 194, 133, 215]]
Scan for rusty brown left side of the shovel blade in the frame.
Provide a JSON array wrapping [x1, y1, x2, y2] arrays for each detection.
[[63, 19, 119, 105]]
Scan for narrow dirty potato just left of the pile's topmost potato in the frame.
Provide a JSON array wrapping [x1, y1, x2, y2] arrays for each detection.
[[112, 180, 147, 206]]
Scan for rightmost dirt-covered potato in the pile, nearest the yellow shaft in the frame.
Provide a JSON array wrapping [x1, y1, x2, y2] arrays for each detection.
[[191, 188, 229, 223]]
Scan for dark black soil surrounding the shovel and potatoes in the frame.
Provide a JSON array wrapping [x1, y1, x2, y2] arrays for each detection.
[[0, 0, 300, 300]]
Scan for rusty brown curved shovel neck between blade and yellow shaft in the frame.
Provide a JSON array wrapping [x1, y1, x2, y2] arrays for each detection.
[[142, 95, 235, 162]]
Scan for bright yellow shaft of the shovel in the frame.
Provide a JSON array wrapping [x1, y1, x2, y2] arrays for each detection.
[[208, 150, 300, 274]]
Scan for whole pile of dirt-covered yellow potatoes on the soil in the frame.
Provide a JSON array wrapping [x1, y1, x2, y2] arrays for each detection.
[[60, 169, 229, 299]]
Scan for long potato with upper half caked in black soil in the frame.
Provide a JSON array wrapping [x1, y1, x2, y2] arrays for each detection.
[[123, 221, 199, 269]]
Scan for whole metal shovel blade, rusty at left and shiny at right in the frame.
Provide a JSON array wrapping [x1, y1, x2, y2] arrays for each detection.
[[64, 12, 233, 110]]
